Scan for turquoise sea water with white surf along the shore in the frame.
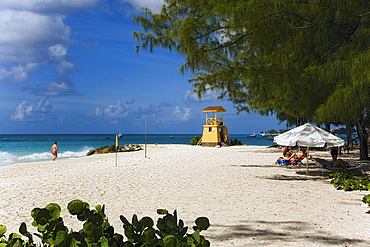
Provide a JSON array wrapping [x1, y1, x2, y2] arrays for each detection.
[[0, 134, 273, 166]]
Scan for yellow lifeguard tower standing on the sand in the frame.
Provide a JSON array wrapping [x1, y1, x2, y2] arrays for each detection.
[[201, 106, 229, 147]]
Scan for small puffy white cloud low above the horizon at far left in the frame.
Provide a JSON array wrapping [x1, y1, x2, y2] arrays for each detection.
[[11, 98, 53, 121]]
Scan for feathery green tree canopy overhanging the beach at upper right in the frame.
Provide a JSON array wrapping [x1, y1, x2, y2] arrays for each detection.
[[134, 0, 370, 156]]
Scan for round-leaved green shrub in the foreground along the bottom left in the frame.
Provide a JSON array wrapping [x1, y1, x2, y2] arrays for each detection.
[[0, 200, 210, 247]]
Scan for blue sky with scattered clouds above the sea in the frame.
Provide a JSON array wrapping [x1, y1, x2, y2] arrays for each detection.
[[0, 0, 285, 134]]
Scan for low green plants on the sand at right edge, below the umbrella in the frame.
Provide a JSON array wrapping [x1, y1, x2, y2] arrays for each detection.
[[329, 170, 370, 191]]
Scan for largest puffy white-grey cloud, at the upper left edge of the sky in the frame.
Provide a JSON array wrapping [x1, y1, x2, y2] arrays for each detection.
[[0, 10, 71, 64]]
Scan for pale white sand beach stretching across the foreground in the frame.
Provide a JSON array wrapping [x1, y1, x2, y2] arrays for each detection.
[[0, 145, 370, 246]]
